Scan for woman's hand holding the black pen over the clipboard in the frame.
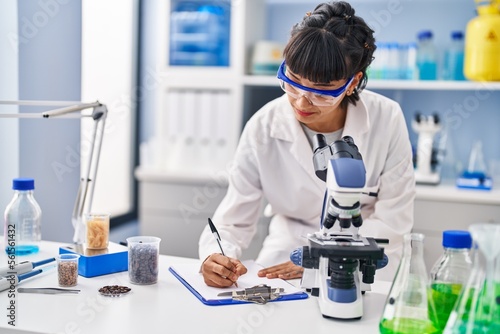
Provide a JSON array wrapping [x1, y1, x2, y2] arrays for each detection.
[[201, 253, 247, 288]]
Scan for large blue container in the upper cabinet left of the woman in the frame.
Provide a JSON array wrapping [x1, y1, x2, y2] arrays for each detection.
[[169, 0, 231, 66]]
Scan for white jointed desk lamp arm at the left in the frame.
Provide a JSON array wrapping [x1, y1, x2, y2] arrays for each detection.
[[0, 101, 108, 244]]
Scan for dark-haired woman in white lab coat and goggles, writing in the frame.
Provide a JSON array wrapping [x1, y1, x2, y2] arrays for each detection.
[[199, 2, 415, 287]]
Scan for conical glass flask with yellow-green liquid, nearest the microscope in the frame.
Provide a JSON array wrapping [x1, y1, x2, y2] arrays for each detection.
[[379, 233, 440, 334]]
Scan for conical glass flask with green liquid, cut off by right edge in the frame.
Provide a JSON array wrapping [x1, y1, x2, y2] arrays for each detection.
[[444, 223, 500, 334]]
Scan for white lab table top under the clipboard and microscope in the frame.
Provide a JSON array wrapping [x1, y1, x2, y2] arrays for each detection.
[[0, 241, 390, 334]]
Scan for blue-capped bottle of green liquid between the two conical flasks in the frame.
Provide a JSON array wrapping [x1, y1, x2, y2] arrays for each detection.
[[430, 230, 472, 329]]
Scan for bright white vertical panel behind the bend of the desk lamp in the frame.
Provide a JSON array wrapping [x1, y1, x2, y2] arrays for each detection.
[[82, 0, 140, 217]]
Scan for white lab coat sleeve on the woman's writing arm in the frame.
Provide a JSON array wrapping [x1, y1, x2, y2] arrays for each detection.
[[199, 120, 263, 260]]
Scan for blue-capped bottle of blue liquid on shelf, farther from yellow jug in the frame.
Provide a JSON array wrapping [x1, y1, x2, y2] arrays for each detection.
[[417, 30, 437, 80]]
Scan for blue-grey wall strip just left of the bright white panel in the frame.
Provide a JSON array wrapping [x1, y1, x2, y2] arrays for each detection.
[[16, 0, 81, 242]]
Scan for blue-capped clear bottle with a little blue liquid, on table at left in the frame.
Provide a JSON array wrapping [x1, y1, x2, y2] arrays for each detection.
[[4, 178, 42, 255]]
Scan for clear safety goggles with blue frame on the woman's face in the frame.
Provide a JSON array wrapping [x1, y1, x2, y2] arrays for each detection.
[[277, 61, 354, 107]]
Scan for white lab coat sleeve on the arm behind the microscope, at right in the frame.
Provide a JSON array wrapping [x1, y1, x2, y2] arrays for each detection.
[[362, 107, 415, 280]]
